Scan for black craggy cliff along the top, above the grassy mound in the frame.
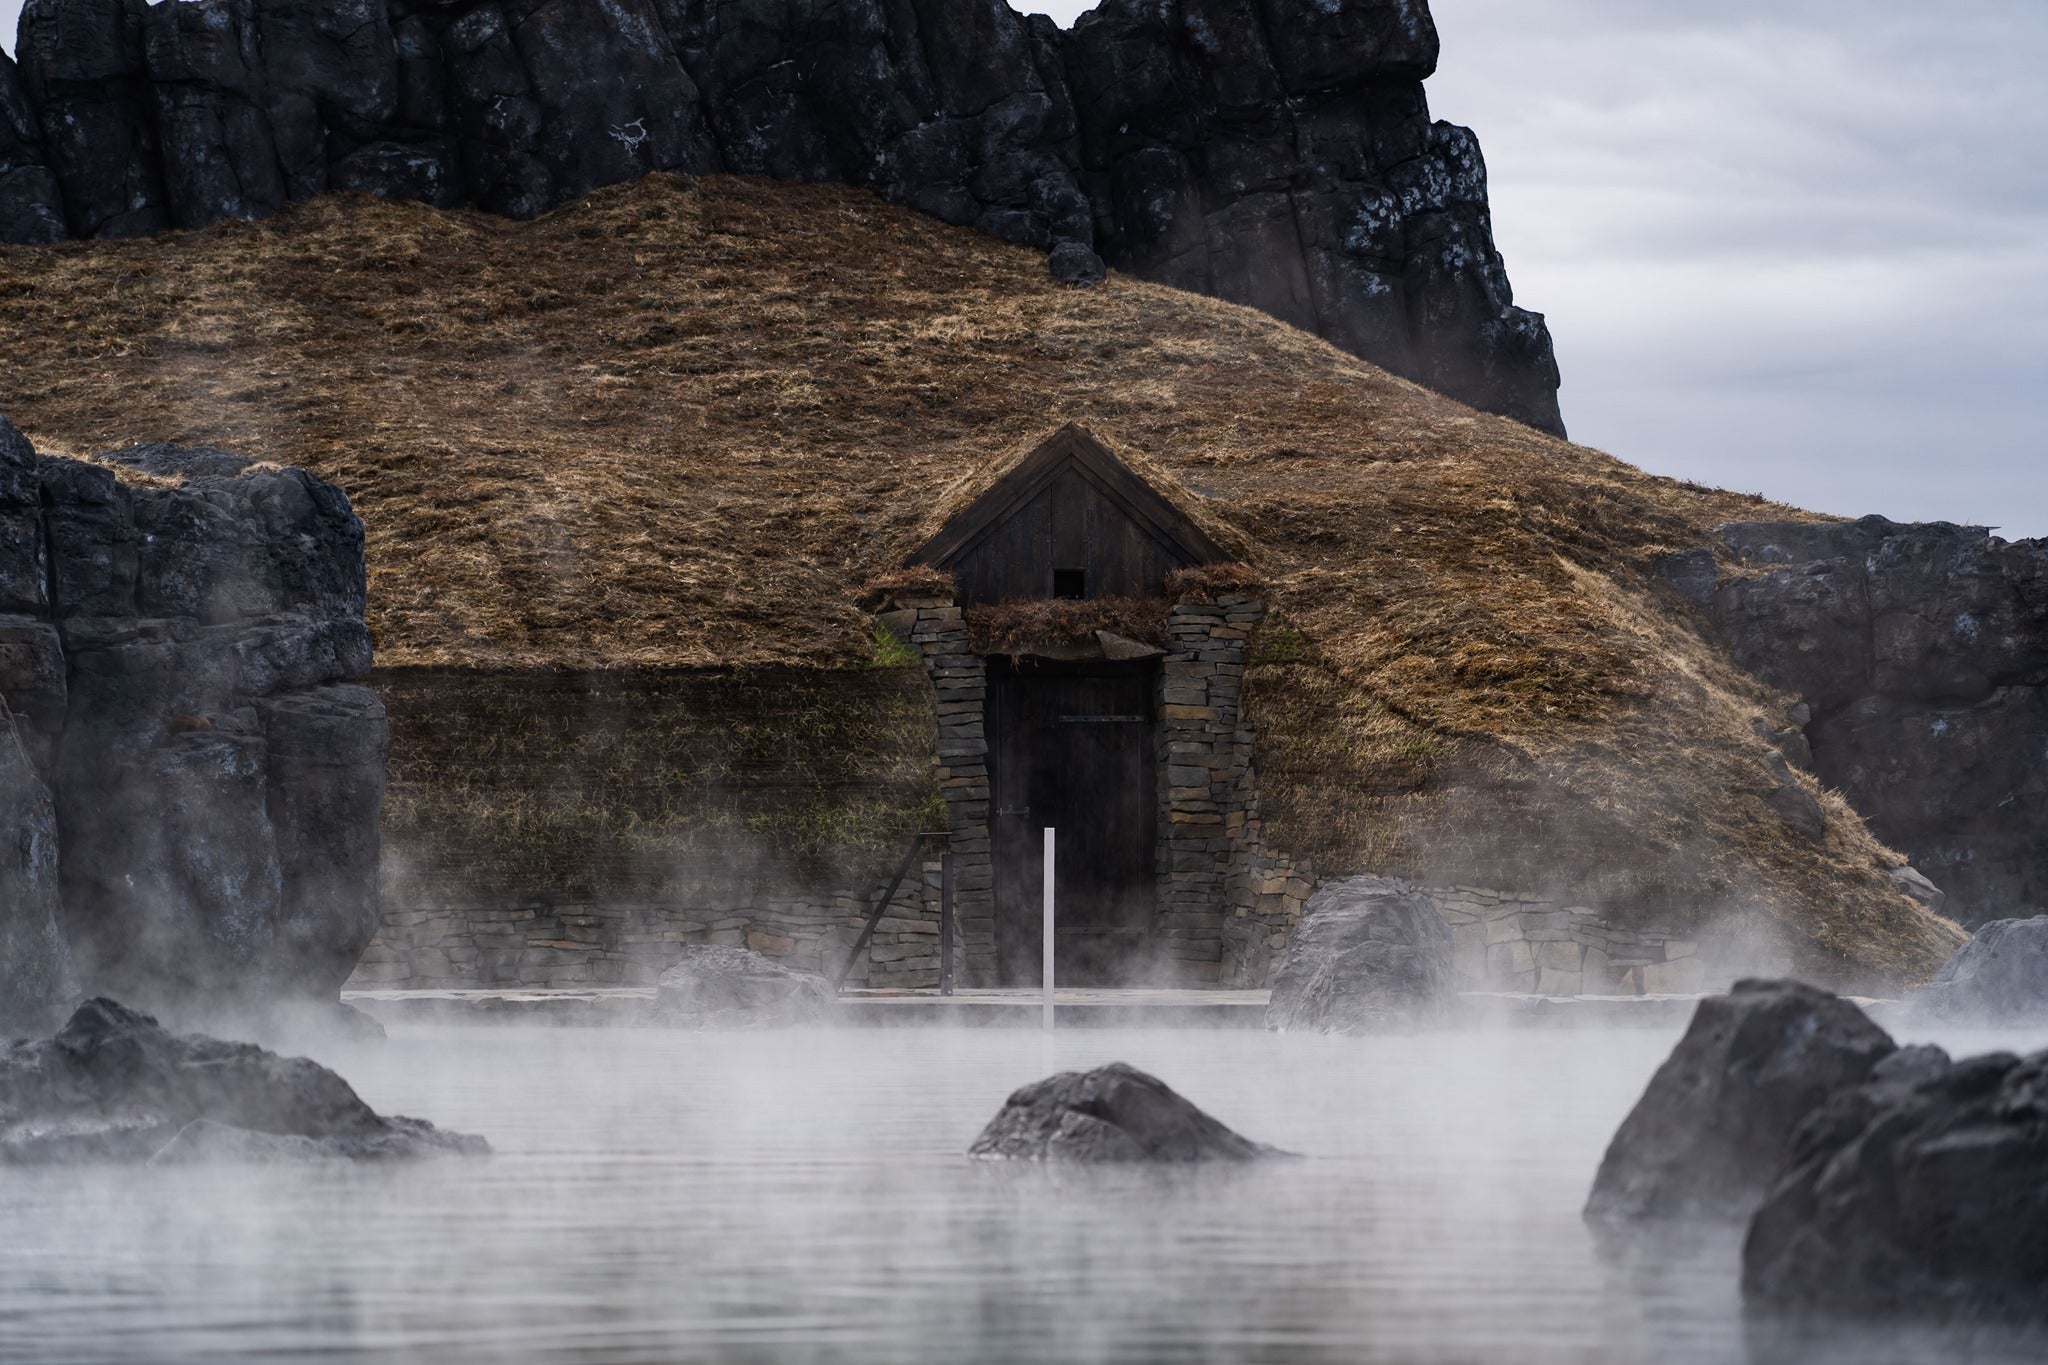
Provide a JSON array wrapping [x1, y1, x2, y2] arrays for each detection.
[[0, 0, 1563, 432]]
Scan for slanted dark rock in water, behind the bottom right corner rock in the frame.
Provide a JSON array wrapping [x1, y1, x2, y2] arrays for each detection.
[[1585, 980, 1898, 1220]]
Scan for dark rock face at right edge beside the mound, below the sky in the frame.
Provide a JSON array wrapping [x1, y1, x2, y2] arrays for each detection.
[[1663, 516, 2048, 925]]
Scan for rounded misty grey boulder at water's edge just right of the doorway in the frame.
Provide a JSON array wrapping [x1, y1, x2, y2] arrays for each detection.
[[1266, 876, 1458, 1033]]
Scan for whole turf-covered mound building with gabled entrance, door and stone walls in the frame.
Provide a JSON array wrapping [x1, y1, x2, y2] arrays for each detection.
[[0, 176, 1960, 993]]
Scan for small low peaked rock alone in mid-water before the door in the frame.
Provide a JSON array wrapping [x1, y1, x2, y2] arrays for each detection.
[[967, 1062, 1284, 1162]]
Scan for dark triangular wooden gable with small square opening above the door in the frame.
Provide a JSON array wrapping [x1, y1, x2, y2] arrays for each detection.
[[909, 426, 1229, 606]]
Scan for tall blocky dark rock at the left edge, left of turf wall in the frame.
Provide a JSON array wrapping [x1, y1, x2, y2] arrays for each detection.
[[0, 420, 387, 1009]]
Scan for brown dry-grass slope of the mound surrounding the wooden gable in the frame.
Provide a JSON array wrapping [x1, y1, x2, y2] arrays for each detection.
[[0, 178, 1960, 984]]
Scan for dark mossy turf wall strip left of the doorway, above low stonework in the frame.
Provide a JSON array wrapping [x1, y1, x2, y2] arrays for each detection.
[[375, 667, 944, 905]]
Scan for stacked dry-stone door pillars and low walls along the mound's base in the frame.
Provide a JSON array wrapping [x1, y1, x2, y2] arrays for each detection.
[[352, 593, 1708, 995]]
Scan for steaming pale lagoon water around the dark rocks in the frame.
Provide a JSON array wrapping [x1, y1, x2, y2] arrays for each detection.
[[0, 1025, 2048, 1365]]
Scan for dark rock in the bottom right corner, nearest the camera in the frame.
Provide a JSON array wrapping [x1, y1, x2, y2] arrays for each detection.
[[1743, 1048, 2048, 1322]]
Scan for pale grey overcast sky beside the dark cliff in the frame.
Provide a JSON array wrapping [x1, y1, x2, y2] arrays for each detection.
[[0, 0, 2048, 536]]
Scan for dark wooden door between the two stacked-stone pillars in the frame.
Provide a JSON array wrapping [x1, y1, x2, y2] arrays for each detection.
[[985, 659, 1159, 986]]
